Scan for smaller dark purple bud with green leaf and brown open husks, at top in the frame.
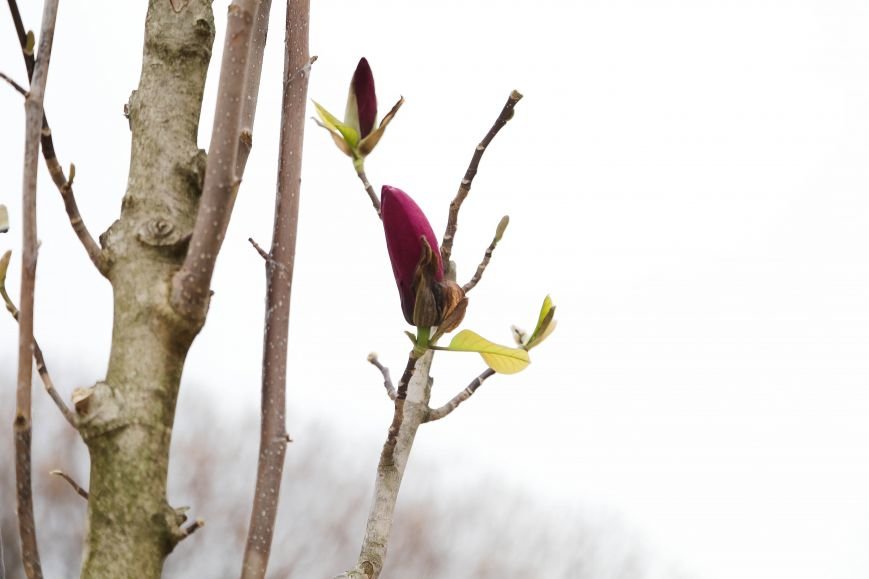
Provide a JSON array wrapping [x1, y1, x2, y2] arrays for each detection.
[[314, 57, 404, 169]]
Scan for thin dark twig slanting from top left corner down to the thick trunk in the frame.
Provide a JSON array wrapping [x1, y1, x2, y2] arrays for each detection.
[[8, 0, 110, 276]]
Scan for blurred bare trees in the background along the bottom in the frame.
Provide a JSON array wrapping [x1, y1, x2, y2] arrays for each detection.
[[0, 386, 685, 579]]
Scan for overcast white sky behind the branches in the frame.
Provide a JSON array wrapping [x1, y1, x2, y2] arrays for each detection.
[[0, 0, 869, 579]]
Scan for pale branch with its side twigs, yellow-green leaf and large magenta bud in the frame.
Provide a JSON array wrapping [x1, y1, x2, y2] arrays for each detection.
[[336, 91, 528, 579]]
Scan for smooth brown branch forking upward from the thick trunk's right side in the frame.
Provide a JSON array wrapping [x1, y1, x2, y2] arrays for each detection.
[[171, 0, 260, 320]]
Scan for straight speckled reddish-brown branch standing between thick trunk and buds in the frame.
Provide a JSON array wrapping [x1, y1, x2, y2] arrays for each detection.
[[241, 0, 310, 579]]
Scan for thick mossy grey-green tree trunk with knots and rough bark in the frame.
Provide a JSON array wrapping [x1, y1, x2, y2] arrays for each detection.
[[76, 0, 214, 579]]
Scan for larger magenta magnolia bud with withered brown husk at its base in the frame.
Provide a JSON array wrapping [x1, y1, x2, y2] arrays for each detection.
[[380, 185, 444, 326]]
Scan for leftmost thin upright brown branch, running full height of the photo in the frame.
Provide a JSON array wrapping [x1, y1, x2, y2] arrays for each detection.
[[13, 0, 58, 579]]
